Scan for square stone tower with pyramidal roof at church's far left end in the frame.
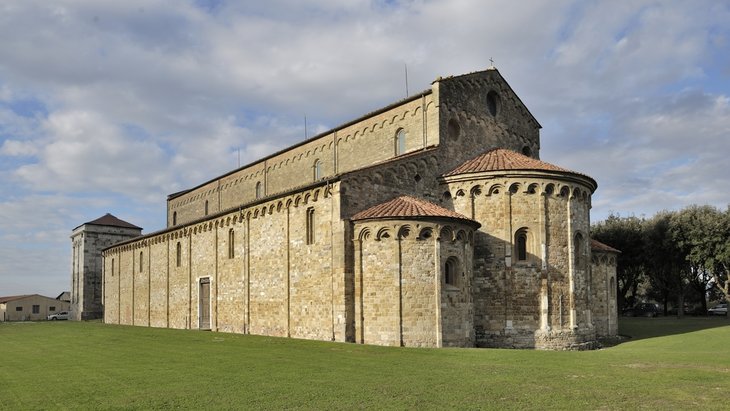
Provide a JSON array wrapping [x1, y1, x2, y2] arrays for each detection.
[[70, 214, 142, 320]]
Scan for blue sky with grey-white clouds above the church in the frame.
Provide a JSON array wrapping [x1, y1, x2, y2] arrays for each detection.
[[0, 0, 730, 297]]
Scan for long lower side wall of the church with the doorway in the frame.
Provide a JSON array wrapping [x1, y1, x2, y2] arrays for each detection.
[[104, 183, 347, 341]]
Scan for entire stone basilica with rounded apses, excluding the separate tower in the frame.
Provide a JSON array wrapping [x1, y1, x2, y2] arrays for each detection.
[[100, 67, 618, 349]]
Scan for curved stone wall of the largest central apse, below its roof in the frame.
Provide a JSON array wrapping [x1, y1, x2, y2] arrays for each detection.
[[442, 173, 595, 348]]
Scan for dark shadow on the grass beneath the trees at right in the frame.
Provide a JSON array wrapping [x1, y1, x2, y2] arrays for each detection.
[[618, 316, 730, 341]]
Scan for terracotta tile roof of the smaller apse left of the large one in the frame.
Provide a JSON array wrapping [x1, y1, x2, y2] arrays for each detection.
[[352, 196, 478, 224]]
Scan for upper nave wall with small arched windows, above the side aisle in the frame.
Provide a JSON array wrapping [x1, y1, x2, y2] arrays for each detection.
[[167, 91, 439, 227]]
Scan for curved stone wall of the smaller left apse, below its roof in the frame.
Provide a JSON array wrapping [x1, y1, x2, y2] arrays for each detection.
[[354, 220, 474, 347]]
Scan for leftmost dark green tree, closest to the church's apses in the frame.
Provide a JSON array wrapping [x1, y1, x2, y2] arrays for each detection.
[[591, 214, 645, 311]]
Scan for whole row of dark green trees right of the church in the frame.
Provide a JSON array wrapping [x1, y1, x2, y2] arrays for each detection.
[[591, 205, 730, 316]]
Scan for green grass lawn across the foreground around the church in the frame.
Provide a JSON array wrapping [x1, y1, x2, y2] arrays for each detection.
[[0, 318, 730, 410]]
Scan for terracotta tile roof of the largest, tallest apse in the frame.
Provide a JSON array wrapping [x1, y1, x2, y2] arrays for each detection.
[[444, 148, 579, 176]]
